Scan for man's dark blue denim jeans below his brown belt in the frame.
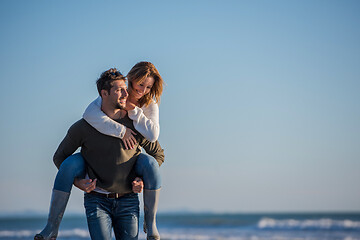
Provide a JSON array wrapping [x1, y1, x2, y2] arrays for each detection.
[[84, 193, 139, 240]]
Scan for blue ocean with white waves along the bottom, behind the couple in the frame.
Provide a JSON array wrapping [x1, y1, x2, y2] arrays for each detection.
[[0, 213, 360, 240]]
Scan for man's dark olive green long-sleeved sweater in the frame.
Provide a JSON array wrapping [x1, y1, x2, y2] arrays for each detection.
[[54, 115, 164, 194]]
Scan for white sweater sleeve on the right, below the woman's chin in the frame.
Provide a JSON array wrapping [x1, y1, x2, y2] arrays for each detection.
[[128, 102, 160, 142]]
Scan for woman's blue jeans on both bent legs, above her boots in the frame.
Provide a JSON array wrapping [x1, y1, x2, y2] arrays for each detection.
[[54, 153, 161, 192]]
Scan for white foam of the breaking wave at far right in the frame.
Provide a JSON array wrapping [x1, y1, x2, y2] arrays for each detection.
[[258, 218, 360, 230]]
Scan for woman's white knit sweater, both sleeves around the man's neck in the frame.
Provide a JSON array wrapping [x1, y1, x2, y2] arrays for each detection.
[[83, 97, 160, 142]]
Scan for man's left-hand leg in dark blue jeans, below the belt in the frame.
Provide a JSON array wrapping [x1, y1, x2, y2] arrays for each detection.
[[84, 194, 112, 240]]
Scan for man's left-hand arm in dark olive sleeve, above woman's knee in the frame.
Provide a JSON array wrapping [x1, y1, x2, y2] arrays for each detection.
[[53, 120, 81, 169]]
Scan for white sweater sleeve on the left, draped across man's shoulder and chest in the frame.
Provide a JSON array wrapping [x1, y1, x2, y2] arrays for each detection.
[[83, 97, 126, 138]]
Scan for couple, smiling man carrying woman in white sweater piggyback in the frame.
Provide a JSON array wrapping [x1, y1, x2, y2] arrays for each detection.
[[34, 62, 164, 240]]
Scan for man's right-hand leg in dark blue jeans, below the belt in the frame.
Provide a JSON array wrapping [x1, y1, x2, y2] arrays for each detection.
[[113, 193, 139, 240]]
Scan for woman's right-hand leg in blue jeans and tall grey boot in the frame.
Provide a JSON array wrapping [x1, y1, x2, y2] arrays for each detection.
[[135, 153, 161, 239]]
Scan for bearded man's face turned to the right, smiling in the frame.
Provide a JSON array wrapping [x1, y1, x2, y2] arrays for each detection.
[[109, 80, 129, 109]]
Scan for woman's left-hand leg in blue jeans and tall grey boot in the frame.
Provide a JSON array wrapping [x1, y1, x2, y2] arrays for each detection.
[[34, 153, 85, 240]]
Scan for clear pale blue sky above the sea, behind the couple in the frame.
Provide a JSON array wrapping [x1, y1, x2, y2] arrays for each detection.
[[0, 0, 360, 213]]
